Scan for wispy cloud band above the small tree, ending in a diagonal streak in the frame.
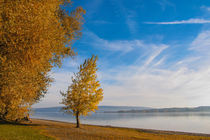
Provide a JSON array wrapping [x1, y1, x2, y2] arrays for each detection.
[[83, 31, 168, 58]]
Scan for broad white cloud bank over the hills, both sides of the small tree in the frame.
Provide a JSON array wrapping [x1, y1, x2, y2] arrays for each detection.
[[36, 31, 210, 107]]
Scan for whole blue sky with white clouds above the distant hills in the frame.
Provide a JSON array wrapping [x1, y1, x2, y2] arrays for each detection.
[[33, 0, 210, 107]]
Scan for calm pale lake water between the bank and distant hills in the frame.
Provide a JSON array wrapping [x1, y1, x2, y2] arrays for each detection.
[[32, 108, 210, 134]]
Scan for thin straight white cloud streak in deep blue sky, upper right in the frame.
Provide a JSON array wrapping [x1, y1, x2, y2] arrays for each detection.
[[144, 18, 210, 25]]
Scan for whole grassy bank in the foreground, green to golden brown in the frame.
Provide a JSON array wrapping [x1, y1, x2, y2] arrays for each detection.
[[0, 119, 210, 140]]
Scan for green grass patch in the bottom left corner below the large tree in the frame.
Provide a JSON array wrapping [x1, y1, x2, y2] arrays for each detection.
[[0, 124, 54, 140]]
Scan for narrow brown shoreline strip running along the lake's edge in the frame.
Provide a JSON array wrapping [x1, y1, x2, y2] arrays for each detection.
[[32, 118, 210, 137]]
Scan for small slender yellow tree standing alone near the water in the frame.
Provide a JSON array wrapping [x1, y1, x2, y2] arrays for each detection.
[[61, 56, 103, 128]]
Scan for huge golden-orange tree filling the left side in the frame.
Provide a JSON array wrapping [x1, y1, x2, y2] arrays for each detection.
[[0, 0, 85, 121]]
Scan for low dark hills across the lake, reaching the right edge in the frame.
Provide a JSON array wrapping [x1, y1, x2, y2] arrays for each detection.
[[105, 106, 210, 113]]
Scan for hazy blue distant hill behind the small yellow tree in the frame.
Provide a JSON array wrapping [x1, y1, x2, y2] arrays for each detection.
[[33, 106, 152, 113]]
